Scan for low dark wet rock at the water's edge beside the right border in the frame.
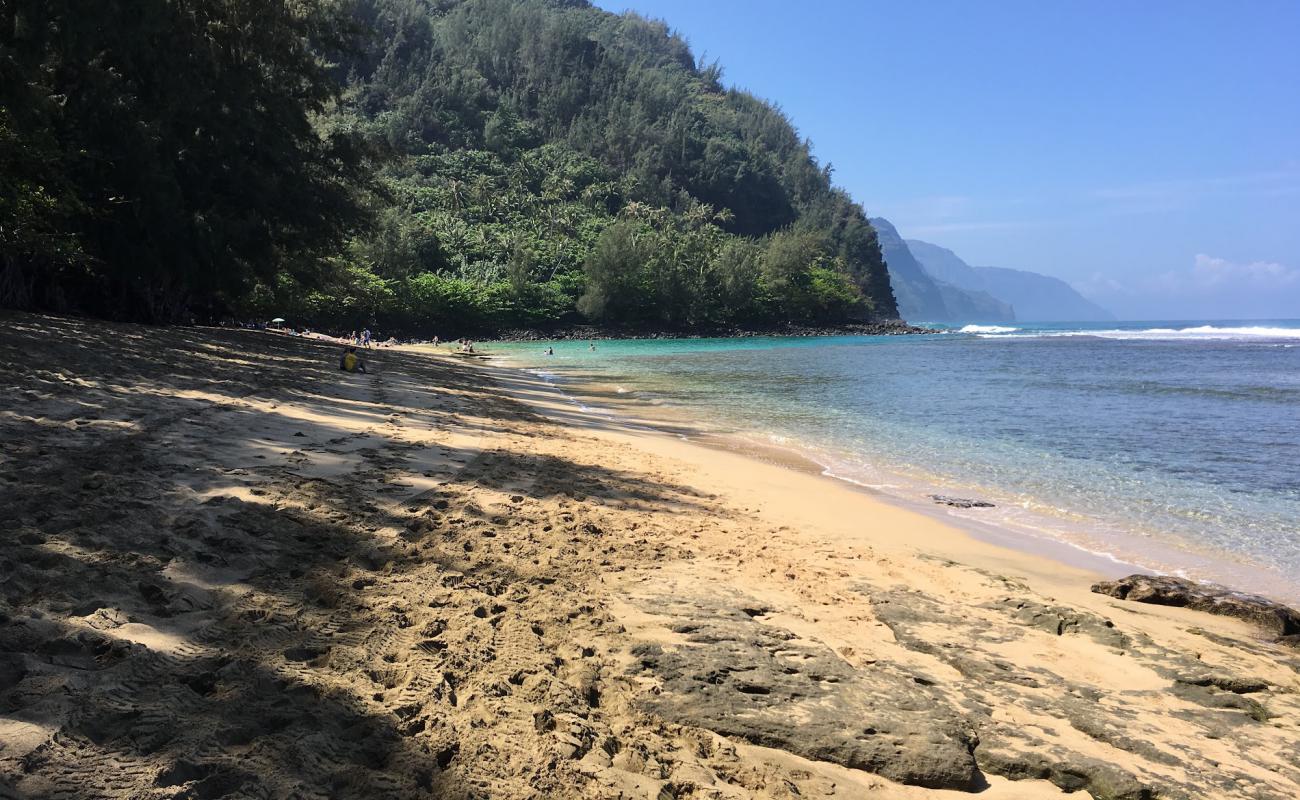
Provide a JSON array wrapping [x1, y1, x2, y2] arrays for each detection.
[[1092, 575, 1300, 647]]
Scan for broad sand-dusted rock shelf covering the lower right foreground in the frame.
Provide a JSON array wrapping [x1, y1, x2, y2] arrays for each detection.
[[628, 565, 1300, 800]]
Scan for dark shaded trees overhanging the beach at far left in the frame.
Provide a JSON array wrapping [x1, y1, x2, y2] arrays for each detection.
[[0, 0, 379, 320]]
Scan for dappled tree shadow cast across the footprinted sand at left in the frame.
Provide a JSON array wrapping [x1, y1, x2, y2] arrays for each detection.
[[0, 315, 699, 797]]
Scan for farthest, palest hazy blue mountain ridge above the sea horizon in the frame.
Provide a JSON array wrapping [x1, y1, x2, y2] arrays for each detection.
[[904, 239, 1115, 323]]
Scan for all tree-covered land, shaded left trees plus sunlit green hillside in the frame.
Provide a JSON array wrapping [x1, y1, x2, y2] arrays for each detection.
[[0, 0, 897, 336]]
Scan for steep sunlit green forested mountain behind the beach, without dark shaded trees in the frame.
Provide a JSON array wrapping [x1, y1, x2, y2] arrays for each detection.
[[325, 0, 897, 330]]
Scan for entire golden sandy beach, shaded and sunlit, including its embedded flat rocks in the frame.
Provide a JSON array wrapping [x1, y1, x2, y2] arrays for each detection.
[[0, 315, 1300, 799]]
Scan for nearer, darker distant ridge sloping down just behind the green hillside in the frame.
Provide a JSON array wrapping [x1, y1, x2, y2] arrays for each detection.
[[871, 217, 1015, 323]]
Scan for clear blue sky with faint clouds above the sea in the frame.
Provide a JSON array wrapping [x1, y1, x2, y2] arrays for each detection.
[[597, 0, 1300, 319]]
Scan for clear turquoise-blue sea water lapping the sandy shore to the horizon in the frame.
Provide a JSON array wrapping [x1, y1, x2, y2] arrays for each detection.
[[491, 320, 1300, 600]]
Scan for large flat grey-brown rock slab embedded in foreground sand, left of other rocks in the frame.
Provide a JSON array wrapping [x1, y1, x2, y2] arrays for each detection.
[[633, 598, 983, 791]]
